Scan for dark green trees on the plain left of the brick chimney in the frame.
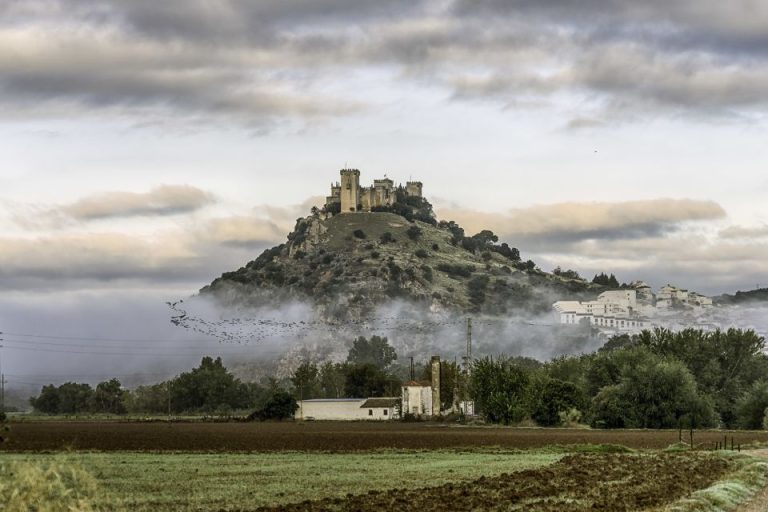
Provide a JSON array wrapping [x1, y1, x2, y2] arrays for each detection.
[[30, 336, 401, 417]]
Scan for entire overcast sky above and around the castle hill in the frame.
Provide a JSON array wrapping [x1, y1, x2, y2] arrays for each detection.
[[0, 0, 768, 382]]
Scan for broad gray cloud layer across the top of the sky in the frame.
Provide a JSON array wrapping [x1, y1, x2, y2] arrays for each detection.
[[0, 0, 768, 126]]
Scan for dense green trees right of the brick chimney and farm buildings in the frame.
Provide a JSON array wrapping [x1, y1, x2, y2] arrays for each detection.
[[470, 329, 768, 429]]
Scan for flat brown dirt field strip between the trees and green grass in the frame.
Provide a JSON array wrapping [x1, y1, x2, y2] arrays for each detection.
[[0, 422, 768, 452]]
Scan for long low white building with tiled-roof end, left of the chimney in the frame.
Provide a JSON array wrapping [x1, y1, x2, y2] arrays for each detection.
[[294, 397, 400, 421]]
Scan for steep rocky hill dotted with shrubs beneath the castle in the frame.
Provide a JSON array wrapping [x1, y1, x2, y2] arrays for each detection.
[[201, 205, 605, 318]]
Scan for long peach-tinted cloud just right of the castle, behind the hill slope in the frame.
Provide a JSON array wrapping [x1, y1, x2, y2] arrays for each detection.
[[438, 199, 725, 245]]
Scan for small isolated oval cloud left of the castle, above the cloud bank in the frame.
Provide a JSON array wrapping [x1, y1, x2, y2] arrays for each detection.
[[53, 185, 214, 221]]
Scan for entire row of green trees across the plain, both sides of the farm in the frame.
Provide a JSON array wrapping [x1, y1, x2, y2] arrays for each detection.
[[31, 329, 768, 429]]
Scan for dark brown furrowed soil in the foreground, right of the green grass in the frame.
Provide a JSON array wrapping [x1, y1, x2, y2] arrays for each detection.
[[257, 454, 730, 512]]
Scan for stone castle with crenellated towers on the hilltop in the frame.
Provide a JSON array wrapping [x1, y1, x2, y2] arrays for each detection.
[[325, 169, 422, 213]]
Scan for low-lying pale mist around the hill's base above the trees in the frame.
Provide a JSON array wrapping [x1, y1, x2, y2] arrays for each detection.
[[0, 290, 768, 402]]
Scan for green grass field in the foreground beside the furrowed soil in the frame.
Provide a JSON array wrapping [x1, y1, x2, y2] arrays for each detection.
[[0, 450, 562, 511]]
